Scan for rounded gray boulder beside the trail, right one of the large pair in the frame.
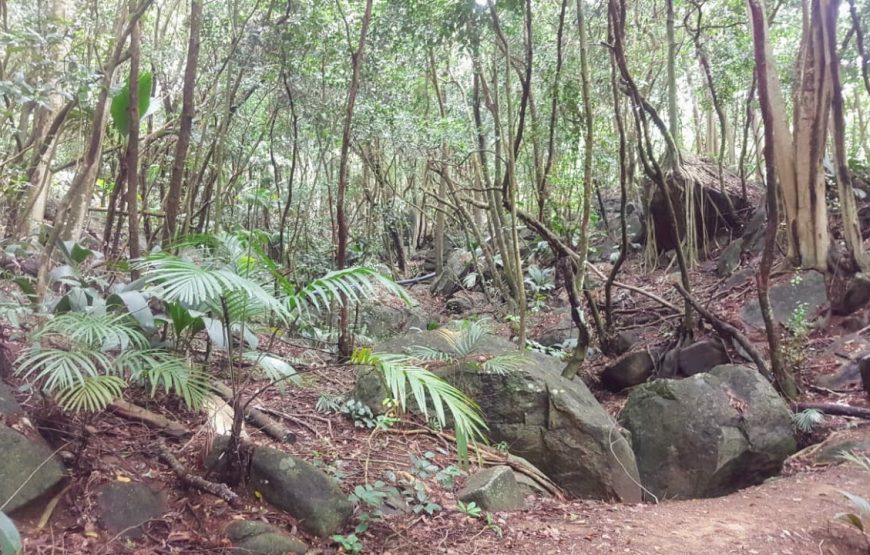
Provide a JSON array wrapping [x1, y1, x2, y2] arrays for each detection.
[[619, 365, 796, 499]]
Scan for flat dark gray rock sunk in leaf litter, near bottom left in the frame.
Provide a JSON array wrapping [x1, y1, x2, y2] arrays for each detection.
[[97, 482, 166, 539]]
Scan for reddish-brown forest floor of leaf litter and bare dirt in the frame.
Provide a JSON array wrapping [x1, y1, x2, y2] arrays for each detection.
[[8, 249, 870, 555]]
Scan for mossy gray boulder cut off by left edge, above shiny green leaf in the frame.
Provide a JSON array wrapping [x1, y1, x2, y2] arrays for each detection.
[[0, 424, 65, 513]]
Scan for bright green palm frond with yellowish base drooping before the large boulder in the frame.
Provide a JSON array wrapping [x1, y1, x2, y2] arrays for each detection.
[[352, 349, 487, 460]]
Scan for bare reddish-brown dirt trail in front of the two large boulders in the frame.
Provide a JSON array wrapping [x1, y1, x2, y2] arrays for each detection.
[[448, 465, 870, 555]]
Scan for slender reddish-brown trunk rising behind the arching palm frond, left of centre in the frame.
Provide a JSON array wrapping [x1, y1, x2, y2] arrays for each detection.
[[335, 0, 372, 357]]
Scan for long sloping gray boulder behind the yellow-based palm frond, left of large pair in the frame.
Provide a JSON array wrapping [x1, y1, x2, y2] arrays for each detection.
[[353, 331, 641, 502]]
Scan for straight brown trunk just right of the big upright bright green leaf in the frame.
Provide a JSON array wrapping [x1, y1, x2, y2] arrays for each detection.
[[163, 0, 202, 246]]
